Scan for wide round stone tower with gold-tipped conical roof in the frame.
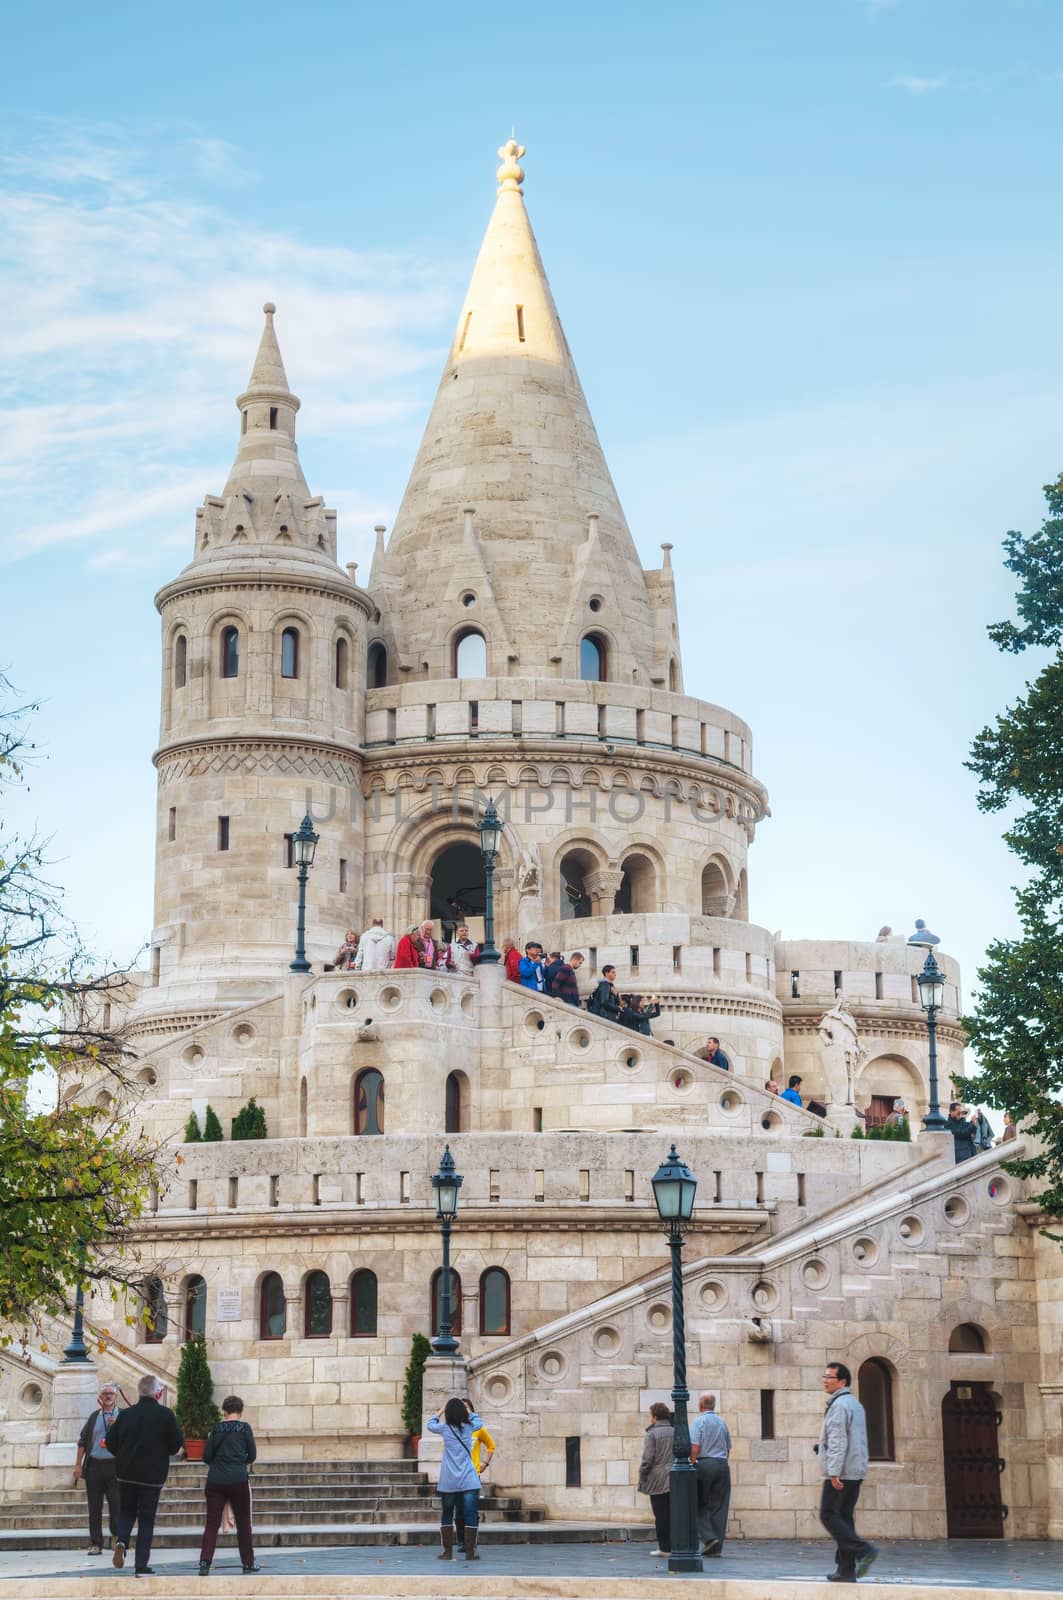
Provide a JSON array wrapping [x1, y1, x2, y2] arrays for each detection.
[[365, 139, 771, 1077]]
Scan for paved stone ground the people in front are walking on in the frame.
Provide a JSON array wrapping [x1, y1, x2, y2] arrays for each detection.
[[0, 1539, 1063, 1597]]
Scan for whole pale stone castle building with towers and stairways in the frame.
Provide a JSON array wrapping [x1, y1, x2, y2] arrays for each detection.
[[0, 149, 1063, 1538]]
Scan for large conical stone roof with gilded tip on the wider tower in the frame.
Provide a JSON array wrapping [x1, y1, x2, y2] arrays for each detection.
[[371, 139, 653, 683]]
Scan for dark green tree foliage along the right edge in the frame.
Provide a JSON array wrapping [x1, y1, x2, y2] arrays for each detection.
[[964, 475, 1063, 1216]]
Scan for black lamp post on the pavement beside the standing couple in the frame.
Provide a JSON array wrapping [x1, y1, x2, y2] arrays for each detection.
[[653, 1146, 704, 1573]]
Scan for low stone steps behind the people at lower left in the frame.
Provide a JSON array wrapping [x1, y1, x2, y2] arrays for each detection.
[[0, 1461, 557, 1550]]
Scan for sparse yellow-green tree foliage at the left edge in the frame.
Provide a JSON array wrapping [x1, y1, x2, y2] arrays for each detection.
[[0, 677, 162, 1344]]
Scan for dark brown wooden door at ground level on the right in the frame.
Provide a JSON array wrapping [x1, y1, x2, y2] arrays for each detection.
[[941, 1384, 1007, 1539]]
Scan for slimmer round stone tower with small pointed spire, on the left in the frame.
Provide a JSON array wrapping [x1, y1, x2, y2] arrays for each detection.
[[152, 304, 373, 989]]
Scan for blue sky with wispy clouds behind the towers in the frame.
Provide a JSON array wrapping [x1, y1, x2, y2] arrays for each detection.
[[0, 0, 1063, 1017]]
